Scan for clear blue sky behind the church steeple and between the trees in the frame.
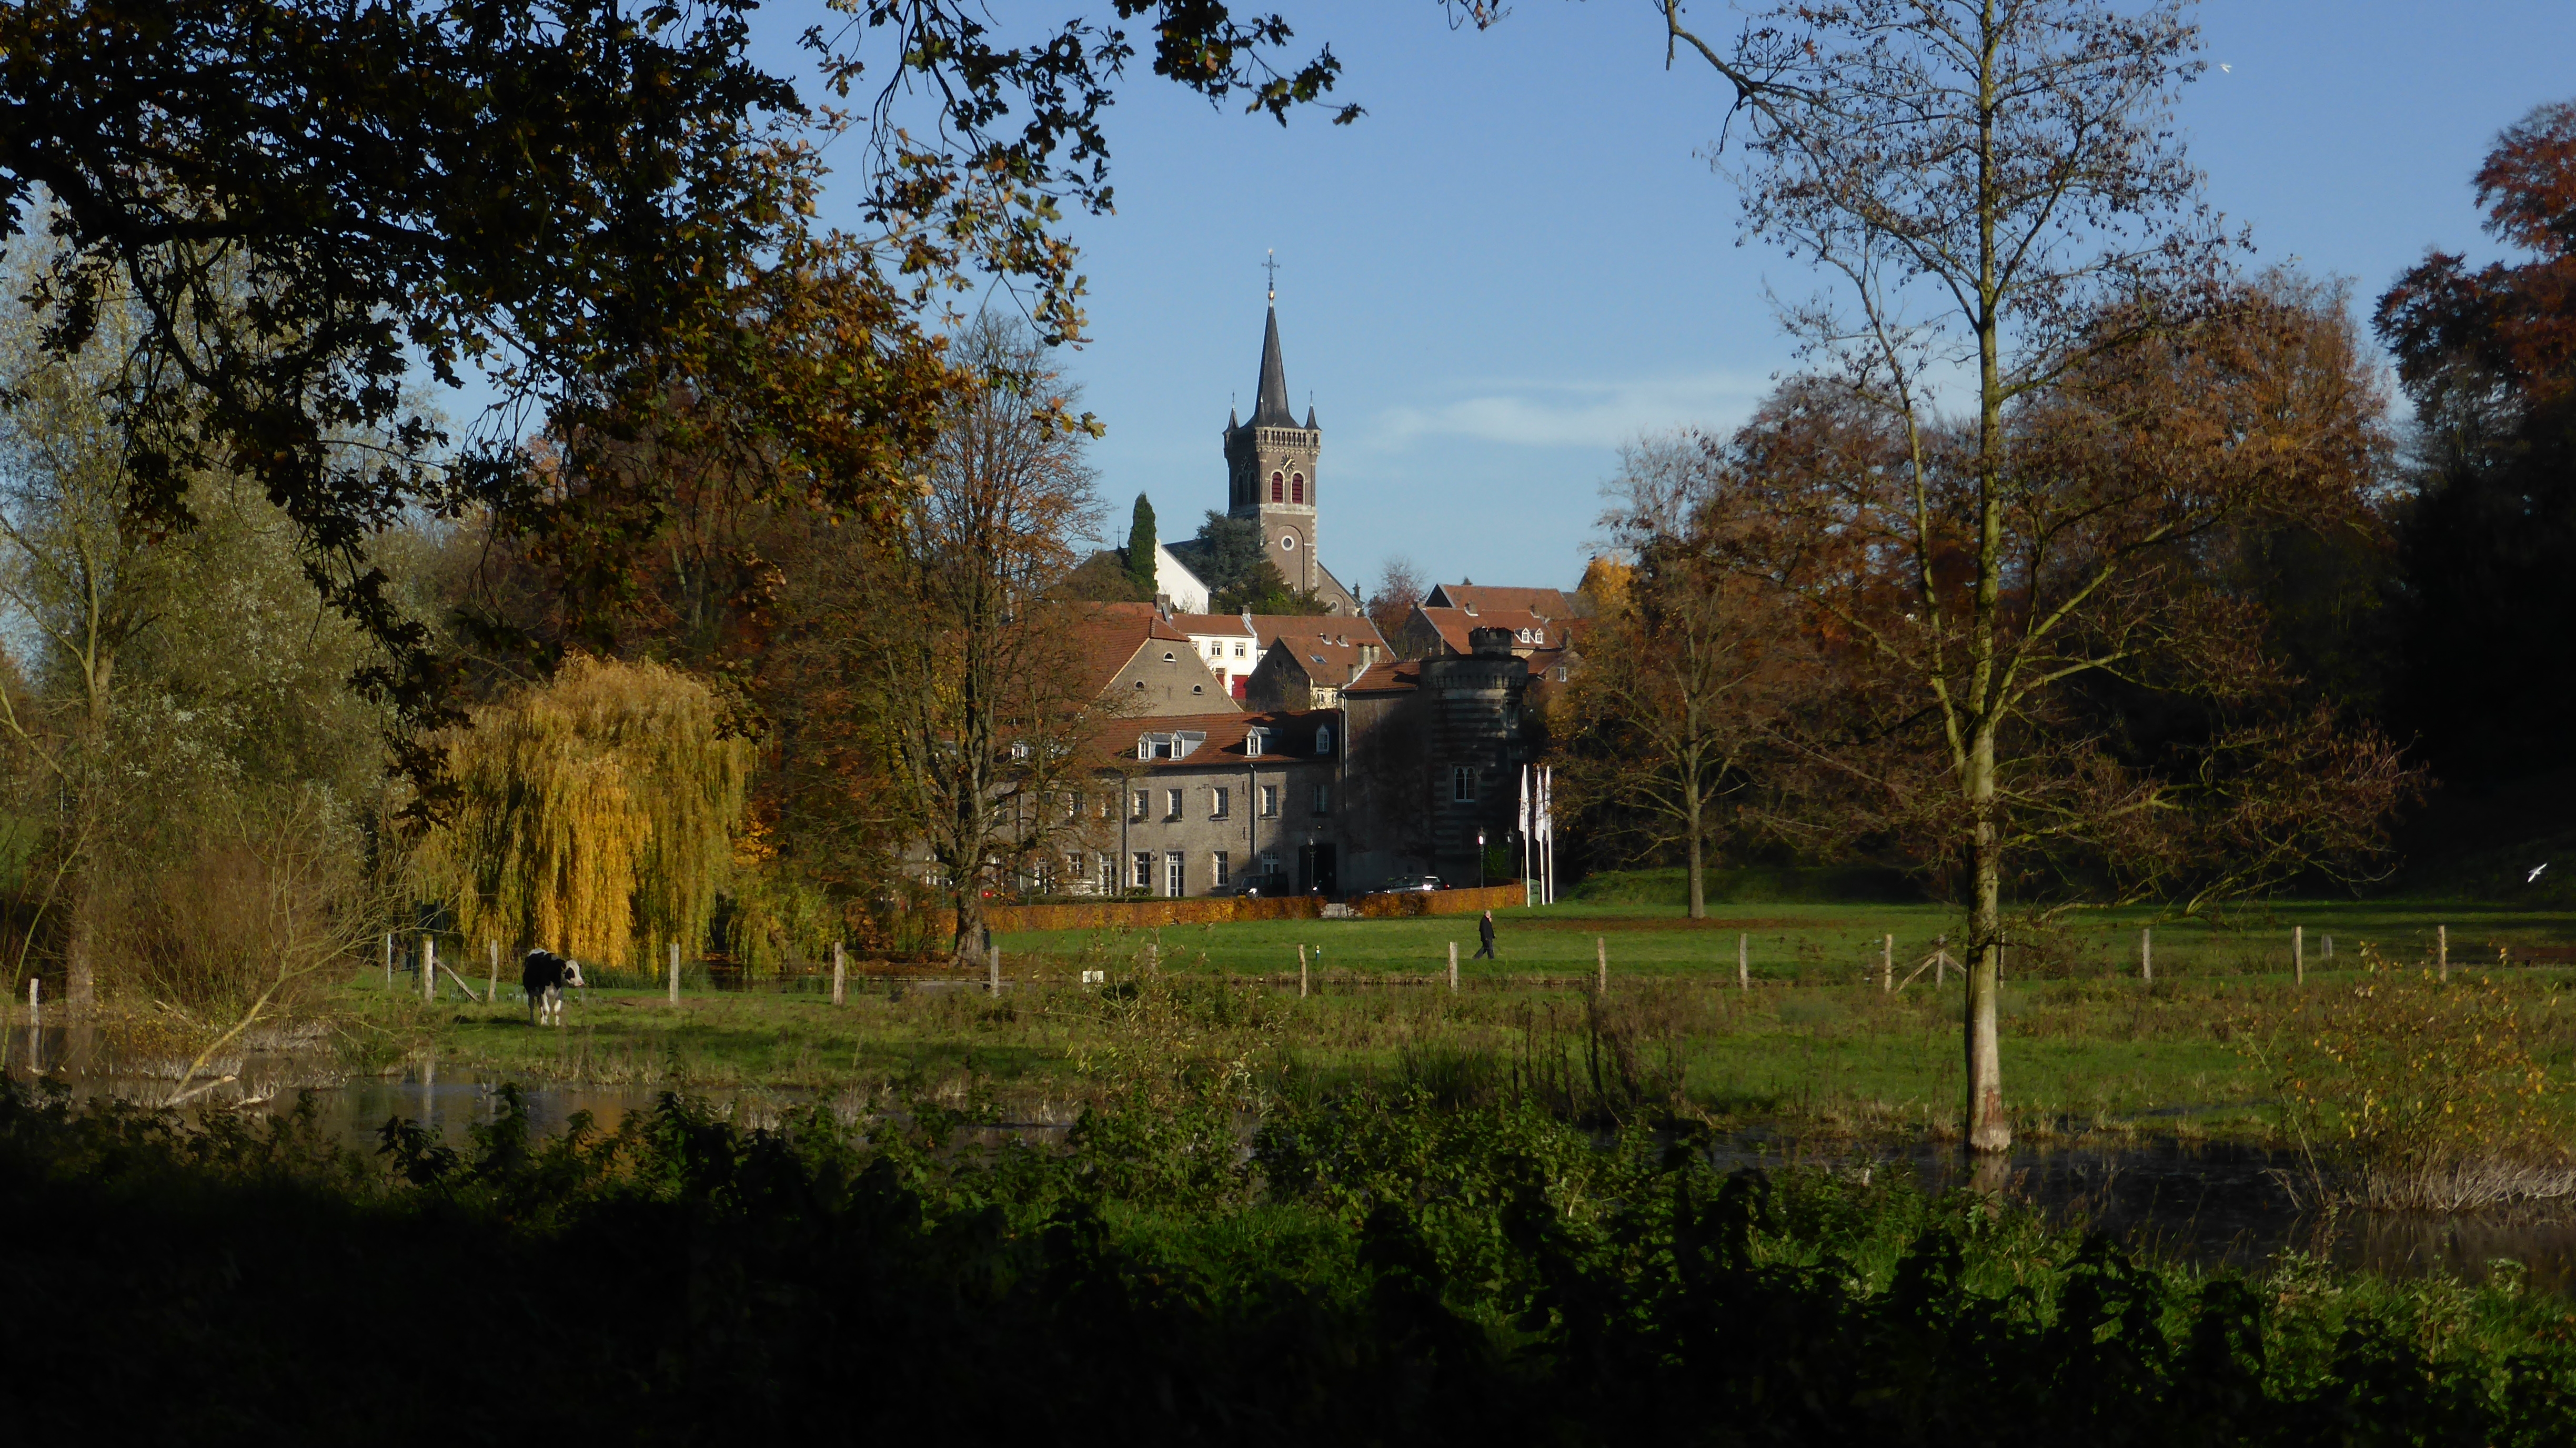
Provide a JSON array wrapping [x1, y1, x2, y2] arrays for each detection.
[[770, 0, 2576, 595]]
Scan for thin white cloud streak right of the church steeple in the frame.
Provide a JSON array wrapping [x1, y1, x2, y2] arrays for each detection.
[[1368, 371, 1770, 448]]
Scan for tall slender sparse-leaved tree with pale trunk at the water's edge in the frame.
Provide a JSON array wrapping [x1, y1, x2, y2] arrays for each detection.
[[1628, 0, 2411, 1152]]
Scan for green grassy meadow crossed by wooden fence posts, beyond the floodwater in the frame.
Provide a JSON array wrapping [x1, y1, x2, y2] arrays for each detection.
[[337, 904, 2576, 1136]]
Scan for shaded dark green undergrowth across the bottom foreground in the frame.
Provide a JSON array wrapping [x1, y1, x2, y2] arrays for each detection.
[[0, 1090, 2576, 1445]]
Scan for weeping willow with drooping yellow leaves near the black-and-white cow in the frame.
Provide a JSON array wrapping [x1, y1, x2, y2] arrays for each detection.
[[417, 657, 752, 969]]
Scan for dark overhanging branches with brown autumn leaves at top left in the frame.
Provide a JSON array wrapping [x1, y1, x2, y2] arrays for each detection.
[[0, 0, 1352, 747]]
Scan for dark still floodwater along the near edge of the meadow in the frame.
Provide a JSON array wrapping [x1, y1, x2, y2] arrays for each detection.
[[8, 1025, 2576, 1296]]
